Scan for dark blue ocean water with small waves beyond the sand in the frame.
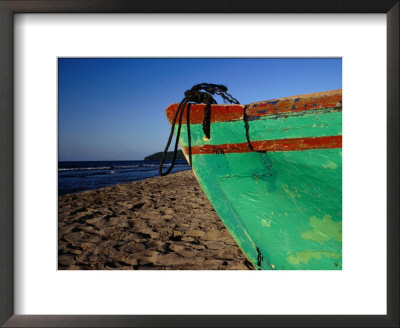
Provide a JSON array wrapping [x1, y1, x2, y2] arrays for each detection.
[[58, 160, 190, 195]]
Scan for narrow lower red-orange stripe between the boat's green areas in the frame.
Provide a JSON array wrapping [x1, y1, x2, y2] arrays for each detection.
[[183, 136, 342, 155]]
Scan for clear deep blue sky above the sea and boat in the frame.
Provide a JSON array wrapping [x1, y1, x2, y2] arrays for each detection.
[[58, 58, 342, 161]]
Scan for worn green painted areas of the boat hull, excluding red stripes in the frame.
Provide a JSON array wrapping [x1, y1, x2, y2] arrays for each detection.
[[164, 89, 342, 270]]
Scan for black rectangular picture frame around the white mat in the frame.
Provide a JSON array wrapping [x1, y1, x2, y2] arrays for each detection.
[[0, 0, 400, 327]]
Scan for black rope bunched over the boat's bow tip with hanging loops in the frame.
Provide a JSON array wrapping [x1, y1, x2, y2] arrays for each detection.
[[158, 83, 239, 176]]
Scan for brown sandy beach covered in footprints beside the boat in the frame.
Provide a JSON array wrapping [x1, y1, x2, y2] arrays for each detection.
[[58, 171, 253, 270]]
